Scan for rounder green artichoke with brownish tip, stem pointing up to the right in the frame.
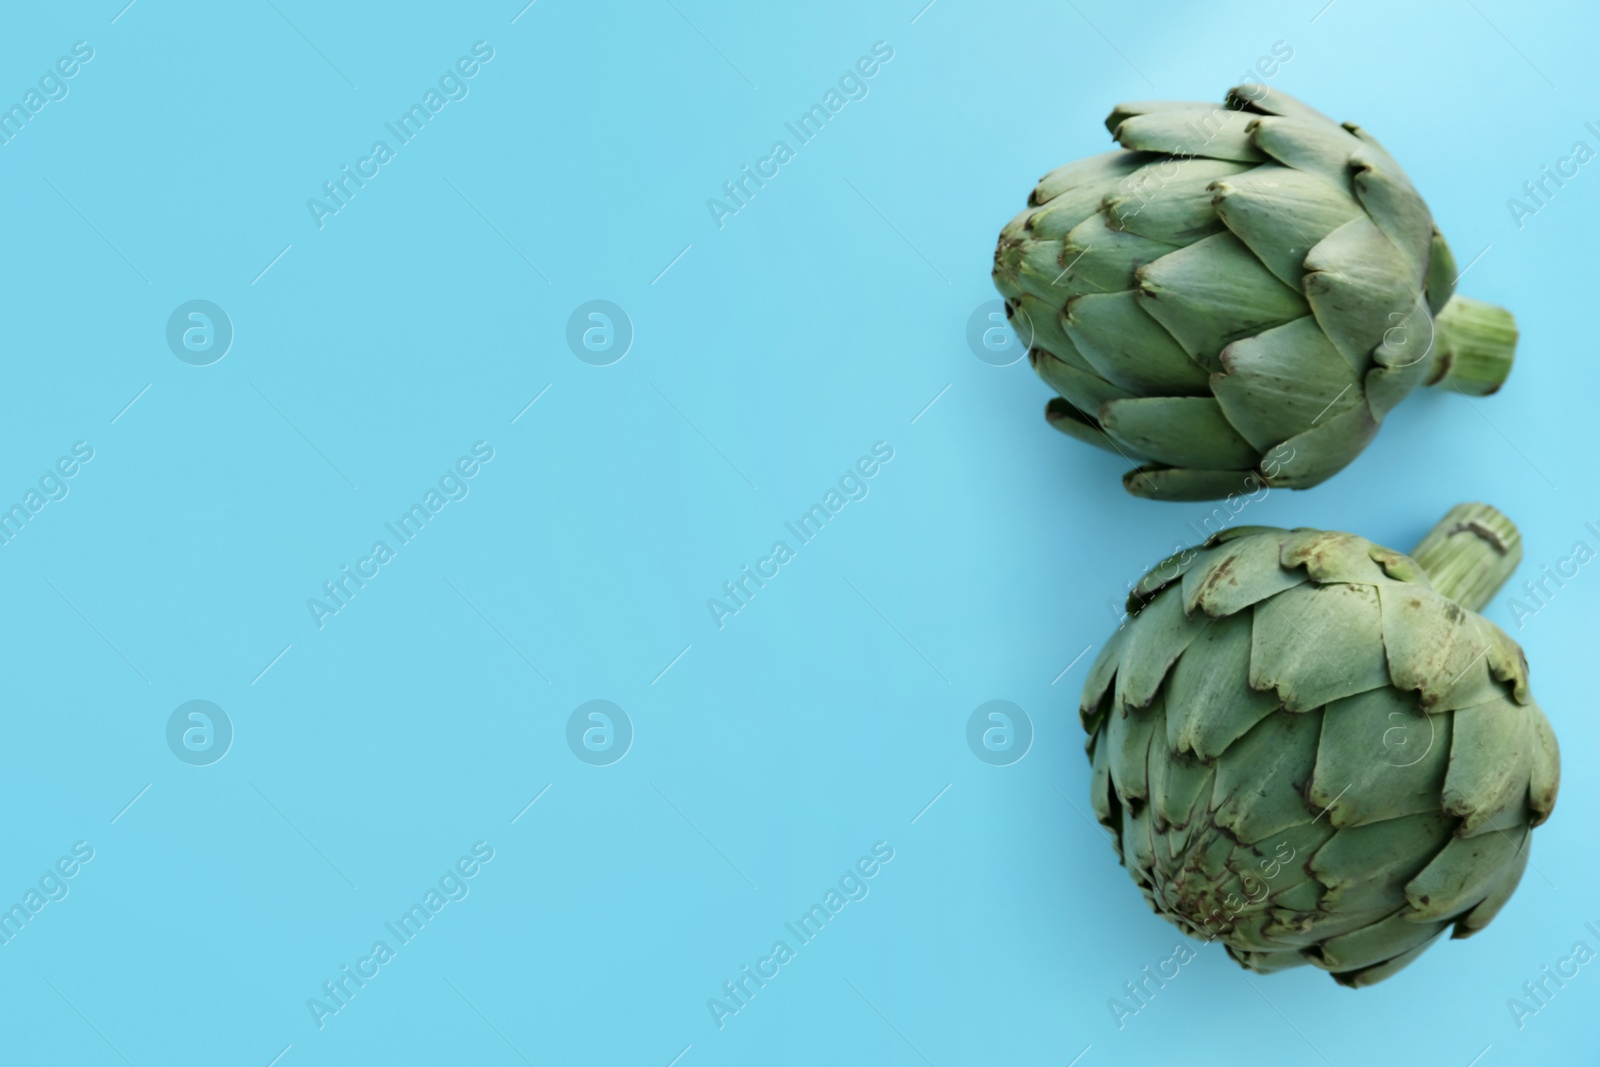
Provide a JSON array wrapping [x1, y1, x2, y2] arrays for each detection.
[[1082, 504, 1560, 985]]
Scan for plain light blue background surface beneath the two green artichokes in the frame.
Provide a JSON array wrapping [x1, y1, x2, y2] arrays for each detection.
[[0, 0, 1600, 1067]]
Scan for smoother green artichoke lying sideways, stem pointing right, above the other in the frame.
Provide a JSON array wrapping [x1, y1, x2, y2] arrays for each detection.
[[994, 86, 1517, 501]]
